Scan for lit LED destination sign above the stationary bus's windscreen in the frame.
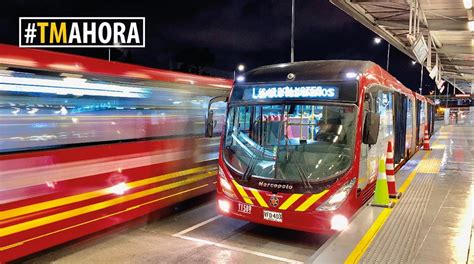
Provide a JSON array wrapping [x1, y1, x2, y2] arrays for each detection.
[[243, 85, 339, 100]]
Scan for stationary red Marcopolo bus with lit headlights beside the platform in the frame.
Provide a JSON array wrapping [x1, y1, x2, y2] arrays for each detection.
[[208, 60, 434, 233]]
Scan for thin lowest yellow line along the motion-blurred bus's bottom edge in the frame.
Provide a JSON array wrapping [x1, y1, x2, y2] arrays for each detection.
[[0, 184, 208, 251]]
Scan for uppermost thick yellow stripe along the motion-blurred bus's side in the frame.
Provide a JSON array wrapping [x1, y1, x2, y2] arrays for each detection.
[[0, 165, 216, 221]]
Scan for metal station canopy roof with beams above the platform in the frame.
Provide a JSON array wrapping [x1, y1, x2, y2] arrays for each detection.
[[331, 0, 474, 93]]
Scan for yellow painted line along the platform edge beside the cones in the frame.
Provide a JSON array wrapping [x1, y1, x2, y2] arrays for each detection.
[[344, 135, 440, 264]]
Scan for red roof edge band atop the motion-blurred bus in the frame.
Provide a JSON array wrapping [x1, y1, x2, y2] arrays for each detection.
[[0, 44, 232, 89]]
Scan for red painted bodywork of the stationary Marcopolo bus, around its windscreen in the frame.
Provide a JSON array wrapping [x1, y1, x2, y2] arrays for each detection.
[[217, 63, 434, 234]]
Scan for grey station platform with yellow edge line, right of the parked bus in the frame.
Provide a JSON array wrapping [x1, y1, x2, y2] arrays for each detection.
[[309, 122, 474, 263]]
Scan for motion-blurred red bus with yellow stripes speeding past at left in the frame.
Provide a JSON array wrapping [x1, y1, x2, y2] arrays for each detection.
[[0, 45, 232, 262]]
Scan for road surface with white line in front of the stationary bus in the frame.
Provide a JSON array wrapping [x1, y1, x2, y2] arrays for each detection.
[[22, 194, 329, 263]]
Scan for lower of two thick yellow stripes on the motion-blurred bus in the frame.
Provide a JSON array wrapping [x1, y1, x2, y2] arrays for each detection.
[[0, 171, 216, 237]]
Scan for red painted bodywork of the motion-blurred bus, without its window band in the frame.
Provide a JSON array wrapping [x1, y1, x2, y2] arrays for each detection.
[[0, 45, 232, 262]]
